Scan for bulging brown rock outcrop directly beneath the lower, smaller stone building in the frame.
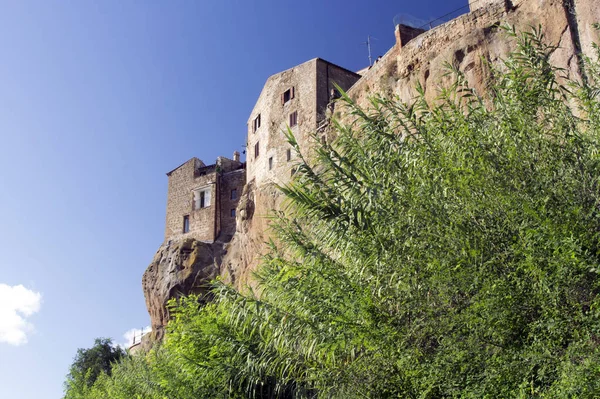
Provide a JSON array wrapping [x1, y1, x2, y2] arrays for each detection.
[[142, 238, 223, 340]]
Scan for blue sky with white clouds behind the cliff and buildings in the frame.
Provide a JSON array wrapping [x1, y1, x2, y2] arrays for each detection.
[[0, 0, 467, 399]]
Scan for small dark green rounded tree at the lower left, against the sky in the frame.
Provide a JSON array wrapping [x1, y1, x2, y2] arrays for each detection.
[[65, 338, 126, 399]]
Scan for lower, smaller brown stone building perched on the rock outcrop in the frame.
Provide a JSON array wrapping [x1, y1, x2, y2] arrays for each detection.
[[165, 151, 246, 242]]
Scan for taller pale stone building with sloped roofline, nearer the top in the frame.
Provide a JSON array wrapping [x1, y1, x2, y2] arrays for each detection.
[[246, 58, 360, 186]]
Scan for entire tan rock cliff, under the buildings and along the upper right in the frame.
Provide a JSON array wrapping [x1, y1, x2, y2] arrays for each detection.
[[142, 0, 600, 339]]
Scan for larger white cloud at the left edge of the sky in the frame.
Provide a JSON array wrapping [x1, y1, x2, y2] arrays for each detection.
[[0, 283, 42, 345]]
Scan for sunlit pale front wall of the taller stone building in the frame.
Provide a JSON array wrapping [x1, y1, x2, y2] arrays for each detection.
[[246, 60, 317, 185]]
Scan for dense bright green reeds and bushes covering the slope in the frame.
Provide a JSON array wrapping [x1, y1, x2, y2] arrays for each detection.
[[67, 26, 600, 399]]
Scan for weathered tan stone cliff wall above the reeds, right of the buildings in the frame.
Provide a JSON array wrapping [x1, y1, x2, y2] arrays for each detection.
[[346, 0, 600, 109]]
